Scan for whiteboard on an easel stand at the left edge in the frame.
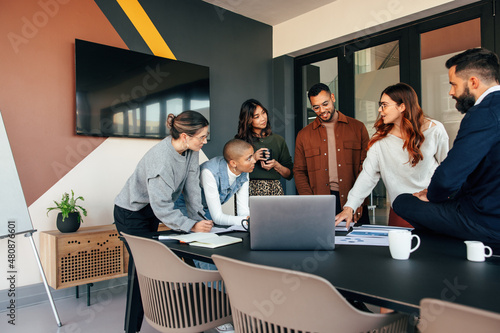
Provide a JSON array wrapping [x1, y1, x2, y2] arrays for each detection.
[[0, 112, 33, 238]]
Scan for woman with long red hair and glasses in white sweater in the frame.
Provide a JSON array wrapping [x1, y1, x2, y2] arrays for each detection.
[[335, 83, 448, 227]]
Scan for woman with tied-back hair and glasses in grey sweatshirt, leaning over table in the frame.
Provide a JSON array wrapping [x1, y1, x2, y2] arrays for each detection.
[[114, 111, 213, 332]]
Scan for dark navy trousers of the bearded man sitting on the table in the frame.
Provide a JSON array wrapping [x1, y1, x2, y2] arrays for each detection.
[[392, 193, 500, 244]]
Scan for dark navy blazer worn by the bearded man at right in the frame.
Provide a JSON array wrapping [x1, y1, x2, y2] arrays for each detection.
[[427, 87, 500, 231]]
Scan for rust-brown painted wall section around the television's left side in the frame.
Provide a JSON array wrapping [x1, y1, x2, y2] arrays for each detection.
[[0, 0, 126, 205]]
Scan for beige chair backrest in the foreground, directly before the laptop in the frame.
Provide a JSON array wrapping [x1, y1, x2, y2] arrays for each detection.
[[212, 255, 408, 333]]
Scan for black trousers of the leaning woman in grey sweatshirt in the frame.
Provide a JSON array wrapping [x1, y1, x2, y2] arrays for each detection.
[[113, 205, 160, 332]]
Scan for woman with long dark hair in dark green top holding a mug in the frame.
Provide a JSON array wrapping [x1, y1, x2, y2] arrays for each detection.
[[235, 99, 293, 196]]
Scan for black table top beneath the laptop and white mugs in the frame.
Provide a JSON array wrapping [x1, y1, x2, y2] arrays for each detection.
[[152, 232, 500, 314]]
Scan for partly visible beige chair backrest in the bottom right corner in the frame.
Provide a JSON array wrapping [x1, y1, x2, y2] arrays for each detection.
[[418, 298, 500, 333]]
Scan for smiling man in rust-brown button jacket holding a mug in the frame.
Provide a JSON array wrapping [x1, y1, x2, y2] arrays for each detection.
[[293, 83, 369, 224]]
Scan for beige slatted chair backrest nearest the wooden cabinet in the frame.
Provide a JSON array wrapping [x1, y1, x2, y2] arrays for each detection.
[[122, 233, 231, 332]]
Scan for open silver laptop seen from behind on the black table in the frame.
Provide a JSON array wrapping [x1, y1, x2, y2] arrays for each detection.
[[250, 195, 335, 250]]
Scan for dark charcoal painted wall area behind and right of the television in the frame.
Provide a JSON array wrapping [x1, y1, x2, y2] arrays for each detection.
[[95, 0, 272, 158]]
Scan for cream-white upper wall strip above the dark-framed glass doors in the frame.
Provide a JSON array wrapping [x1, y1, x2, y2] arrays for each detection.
[[273, 0, 478, 57]]
